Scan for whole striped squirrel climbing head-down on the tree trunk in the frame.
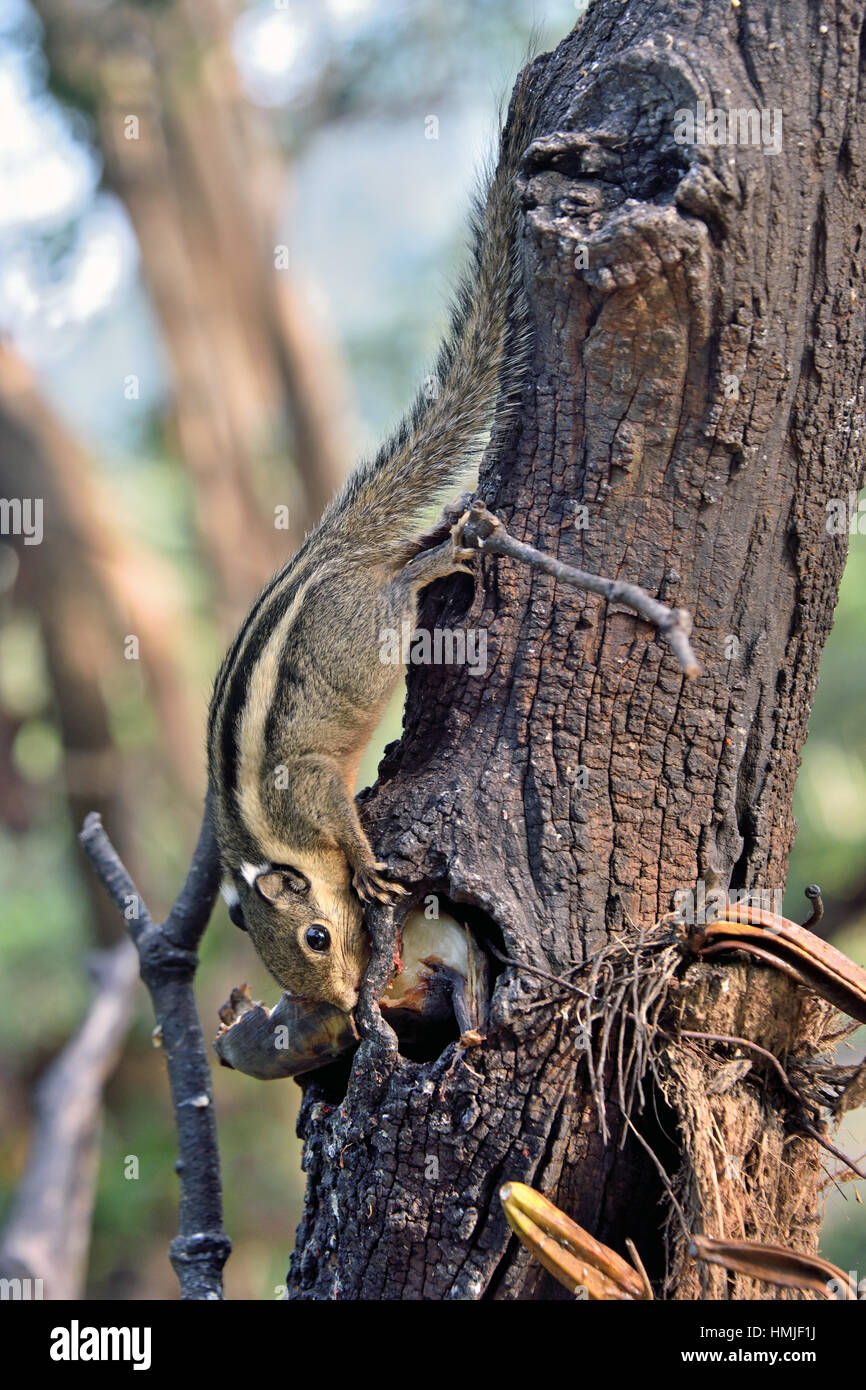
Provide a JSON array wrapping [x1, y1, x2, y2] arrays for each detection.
[[207, 67, 537, 1012]]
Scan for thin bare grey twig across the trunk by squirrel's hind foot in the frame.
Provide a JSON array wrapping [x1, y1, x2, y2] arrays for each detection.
[[455, 500, 701, 678]]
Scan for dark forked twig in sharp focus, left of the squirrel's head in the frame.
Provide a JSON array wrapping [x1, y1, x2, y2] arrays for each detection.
[[79, 796, 231, 1300]]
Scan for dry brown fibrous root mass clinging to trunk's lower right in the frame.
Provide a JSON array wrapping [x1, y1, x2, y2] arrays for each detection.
[[561, 923, 858, 1300]]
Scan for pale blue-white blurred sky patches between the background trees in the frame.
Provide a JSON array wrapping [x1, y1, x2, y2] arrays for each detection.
[[0, 0, 577, 455]]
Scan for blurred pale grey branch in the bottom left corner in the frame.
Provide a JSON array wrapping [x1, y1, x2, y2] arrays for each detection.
[[0, 941, 138, 1298]]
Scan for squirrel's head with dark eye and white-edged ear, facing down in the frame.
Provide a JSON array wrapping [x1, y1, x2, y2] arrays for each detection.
[[222, 853, 370, 1013]]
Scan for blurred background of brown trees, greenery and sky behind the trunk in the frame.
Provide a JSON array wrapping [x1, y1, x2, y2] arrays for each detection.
[[0, 0, 866, 1298]]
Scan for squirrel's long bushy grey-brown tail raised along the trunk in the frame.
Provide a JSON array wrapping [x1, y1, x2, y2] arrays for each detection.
[[316, 64, 538, 559]]
